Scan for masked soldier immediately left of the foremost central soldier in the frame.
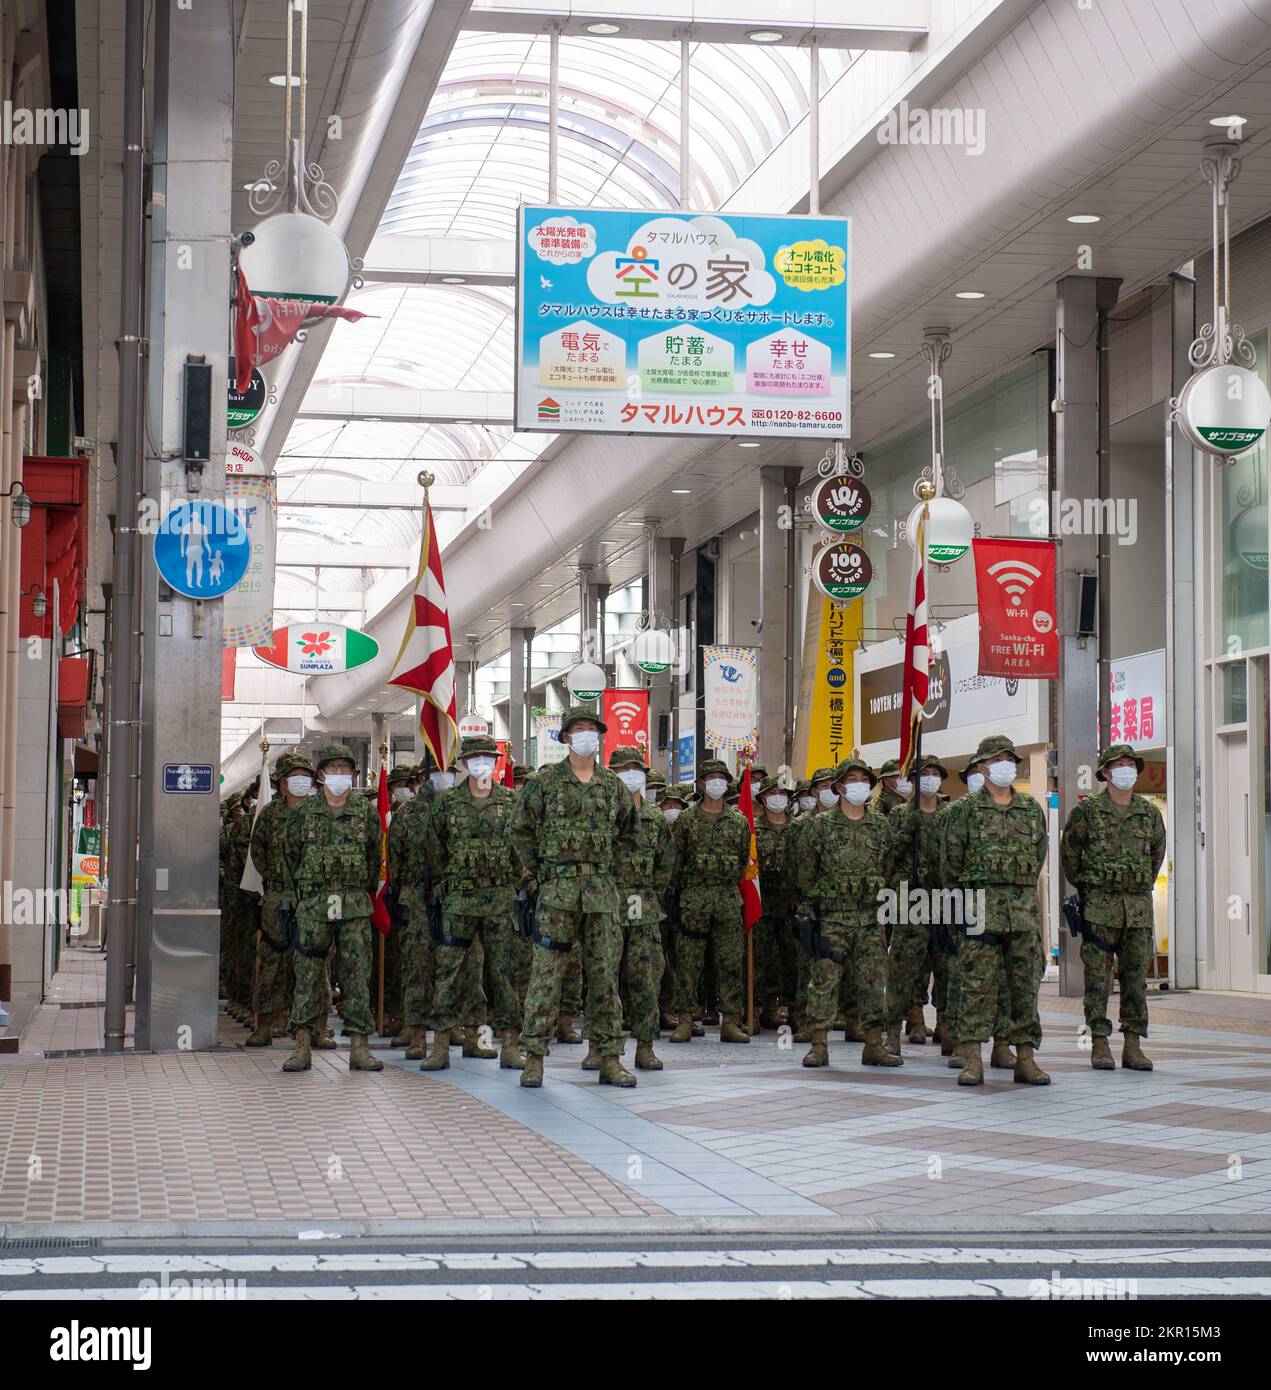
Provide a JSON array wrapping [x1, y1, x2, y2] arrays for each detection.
[[420, 734, 524, 1072]]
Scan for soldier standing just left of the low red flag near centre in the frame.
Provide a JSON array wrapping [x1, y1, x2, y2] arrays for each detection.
[[670, 758, 751, 1043]]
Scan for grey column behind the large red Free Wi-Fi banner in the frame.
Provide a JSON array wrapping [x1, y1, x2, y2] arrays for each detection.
[[1051, 275, 1119, 997]]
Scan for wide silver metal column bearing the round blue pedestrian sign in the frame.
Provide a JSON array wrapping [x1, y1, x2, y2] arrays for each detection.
[[132, 0, 234, 1051]]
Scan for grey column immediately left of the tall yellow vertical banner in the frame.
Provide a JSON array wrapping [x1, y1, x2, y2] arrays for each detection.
[[759, 467, 800, 773]]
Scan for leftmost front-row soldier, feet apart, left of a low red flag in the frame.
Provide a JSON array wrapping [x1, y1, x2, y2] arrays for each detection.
[[280, 744, 384, 1072]]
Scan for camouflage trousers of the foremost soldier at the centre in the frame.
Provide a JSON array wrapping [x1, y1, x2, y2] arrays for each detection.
[[520, 910, 623, 1056]]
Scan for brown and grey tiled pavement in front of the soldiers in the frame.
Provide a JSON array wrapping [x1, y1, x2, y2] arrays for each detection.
[[0, 950, 1271, 1229]]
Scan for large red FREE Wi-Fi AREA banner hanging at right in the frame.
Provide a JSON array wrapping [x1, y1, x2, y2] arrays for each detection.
[[971, 539, 1060, 681]]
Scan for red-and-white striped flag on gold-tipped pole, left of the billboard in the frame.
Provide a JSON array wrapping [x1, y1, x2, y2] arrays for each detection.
[[388, 493, 459, 771]]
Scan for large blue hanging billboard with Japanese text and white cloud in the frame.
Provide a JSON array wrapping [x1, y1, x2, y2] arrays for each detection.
[[516, 207, 851, 438]]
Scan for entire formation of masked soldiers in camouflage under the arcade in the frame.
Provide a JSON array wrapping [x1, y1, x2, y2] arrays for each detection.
[[221, 706, 1165, 1087]]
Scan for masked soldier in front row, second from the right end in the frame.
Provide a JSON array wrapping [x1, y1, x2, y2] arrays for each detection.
[[941, 734, 1050, 1086]]
